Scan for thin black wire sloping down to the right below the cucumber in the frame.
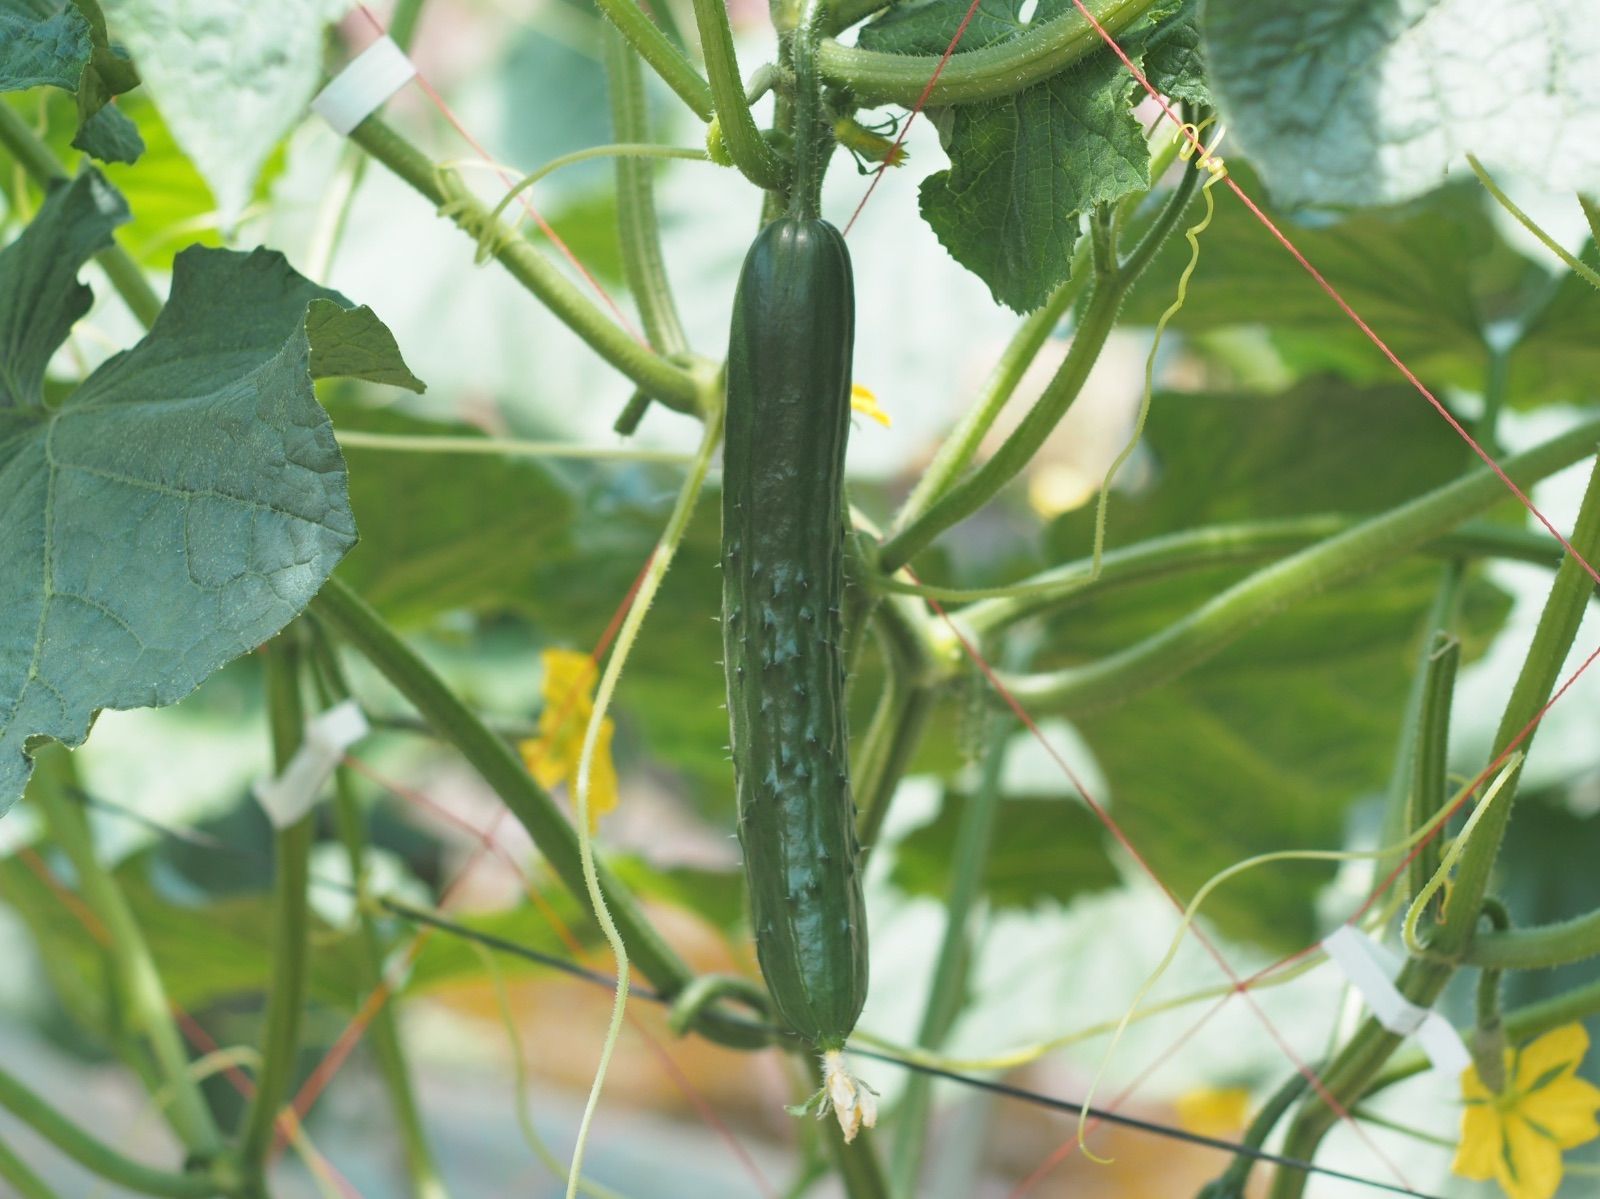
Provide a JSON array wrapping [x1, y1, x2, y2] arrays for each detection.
[[56, 789, 1442, 1199]]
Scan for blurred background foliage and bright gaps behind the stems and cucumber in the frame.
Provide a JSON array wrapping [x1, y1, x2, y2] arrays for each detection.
[[0, 0, 1600, 1199]]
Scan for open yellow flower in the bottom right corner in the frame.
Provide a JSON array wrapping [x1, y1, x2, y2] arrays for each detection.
[[1451, 1023, 1600, 1199]]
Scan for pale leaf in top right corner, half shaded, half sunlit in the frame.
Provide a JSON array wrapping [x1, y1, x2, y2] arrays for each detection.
[[1203, 0, 1600, 205]]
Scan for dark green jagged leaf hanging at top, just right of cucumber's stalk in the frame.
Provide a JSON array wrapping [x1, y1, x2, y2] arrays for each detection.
[[861, 0, 1173, 312]]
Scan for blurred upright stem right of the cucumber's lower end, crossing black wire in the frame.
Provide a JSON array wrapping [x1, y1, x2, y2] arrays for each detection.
[[890, 725, 1010, 1199]]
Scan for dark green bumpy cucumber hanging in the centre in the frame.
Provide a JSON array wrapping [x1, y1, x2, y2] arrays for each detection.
[[722, 218, 867, 1050]]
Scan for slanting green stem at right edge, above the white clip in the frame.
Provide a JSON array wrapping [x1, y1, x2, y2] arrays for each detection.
[[1432, 463, 1600, 956]]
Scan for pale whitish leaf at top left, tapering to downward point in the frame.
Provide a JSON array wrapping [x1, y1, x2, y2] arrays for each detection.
[[104, 0, 347, 223]]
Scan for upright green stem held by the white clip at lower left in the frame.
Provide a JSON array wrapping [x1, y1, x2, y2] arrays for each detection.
[[240, 640, 317, 1171]]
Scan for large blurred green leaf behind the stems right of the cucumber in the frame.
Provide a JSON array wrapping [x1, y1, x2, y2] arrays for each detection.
[[1048, 383, 1506, 948]]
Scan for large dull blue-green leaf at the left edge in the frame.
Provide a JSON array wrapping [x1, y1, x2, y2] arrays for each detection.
[[0, 171, 355, 810]]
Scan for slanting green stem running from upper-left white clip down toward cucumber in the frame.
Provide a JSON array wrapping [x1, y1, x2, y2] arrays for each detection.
[[350, 117, 702, 413]]
